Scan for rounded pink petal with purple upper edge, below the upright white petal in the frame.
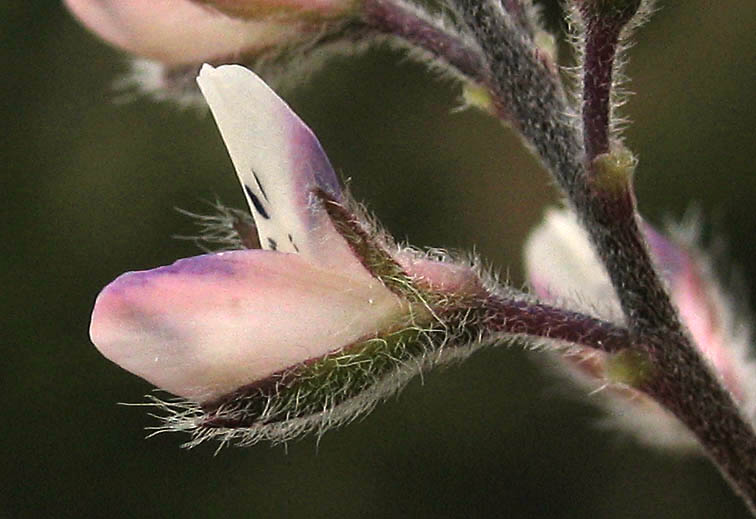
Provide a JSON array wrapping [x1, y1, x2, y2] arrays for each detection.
[[90, 250, 406, 402]]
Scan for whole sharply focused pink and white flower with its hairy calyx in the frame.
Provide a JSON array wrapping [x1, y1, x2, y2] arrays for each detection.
[[91, 65, 482, 442]]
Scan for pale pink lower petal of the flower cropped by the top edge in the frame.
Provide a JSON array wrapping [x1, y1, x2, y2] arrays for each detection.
[[64, 0, 302, 64]]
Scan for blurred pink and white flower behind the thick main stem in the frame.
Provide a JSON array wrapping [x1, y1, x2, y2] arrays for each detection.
[[525, 210, 756, 449]]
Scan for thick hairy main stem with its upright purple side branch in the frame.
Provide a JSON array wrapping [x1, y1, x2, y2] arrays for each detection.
[[448, 0, 756, 512]]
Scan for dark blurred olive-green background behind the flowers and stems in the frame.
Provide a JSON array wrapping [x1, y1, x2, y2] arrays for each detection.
[[0, 0, 756, 519]]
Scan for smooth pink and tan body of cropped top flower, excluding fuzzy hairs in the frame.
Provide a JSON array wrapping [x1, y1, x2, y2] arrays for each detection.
[[65, 0, 354, 65]]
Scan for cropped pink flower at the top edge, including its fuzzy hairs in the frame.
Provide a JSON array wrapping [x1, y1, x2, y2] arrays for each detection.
[[65, 0, 358, 105]]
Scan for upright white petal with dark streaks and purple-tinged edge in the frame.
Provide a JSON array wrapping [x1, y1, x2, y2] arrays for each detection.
[[197, 65, 366, 276]]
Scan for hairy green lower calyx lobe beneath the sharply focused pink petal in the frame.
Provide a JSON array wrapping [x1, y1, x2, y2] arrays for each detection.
[[200, 318, 444, 432]]
